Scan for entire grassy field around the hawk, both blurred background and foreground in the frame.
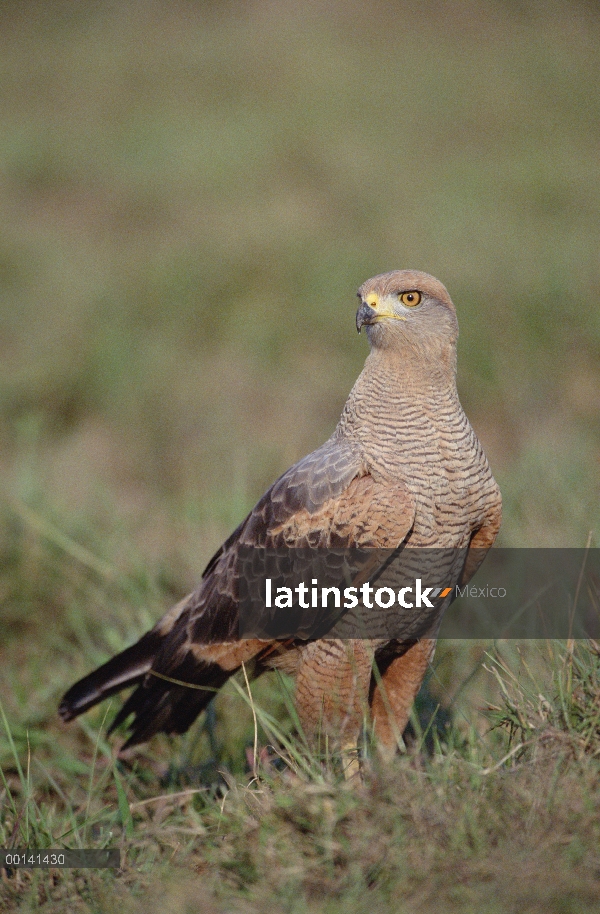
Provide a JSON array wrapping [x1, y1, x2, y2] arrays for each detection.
[[0, 0, 600, 914]]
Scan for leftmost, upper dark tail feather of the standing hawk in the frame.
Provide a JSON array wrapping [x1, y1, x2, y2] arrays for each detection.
[[58, 631, 162, 721]]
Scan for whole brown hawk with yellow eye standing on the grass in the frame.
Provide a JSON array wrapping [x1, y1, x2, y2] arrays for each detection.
[[59, 270, 501, 757]]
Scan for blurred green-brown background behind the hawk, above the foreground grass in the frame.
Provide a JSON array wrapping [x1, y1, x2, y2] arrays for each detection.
[[0, 0, 600, 726]]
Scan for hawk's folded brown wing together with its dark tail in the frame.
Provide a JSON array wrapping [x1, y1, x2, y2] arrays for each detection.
[[60, 437, 415, 745]]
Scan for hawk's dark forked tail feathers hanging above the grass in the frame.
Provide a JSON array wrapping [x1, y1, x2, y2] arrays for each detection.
[[58, 629, 235, 749]]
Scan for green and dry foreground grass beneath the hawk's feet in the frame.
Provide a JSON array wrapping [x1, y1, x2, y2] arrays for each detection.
[[0, 644, 600, 912]]
